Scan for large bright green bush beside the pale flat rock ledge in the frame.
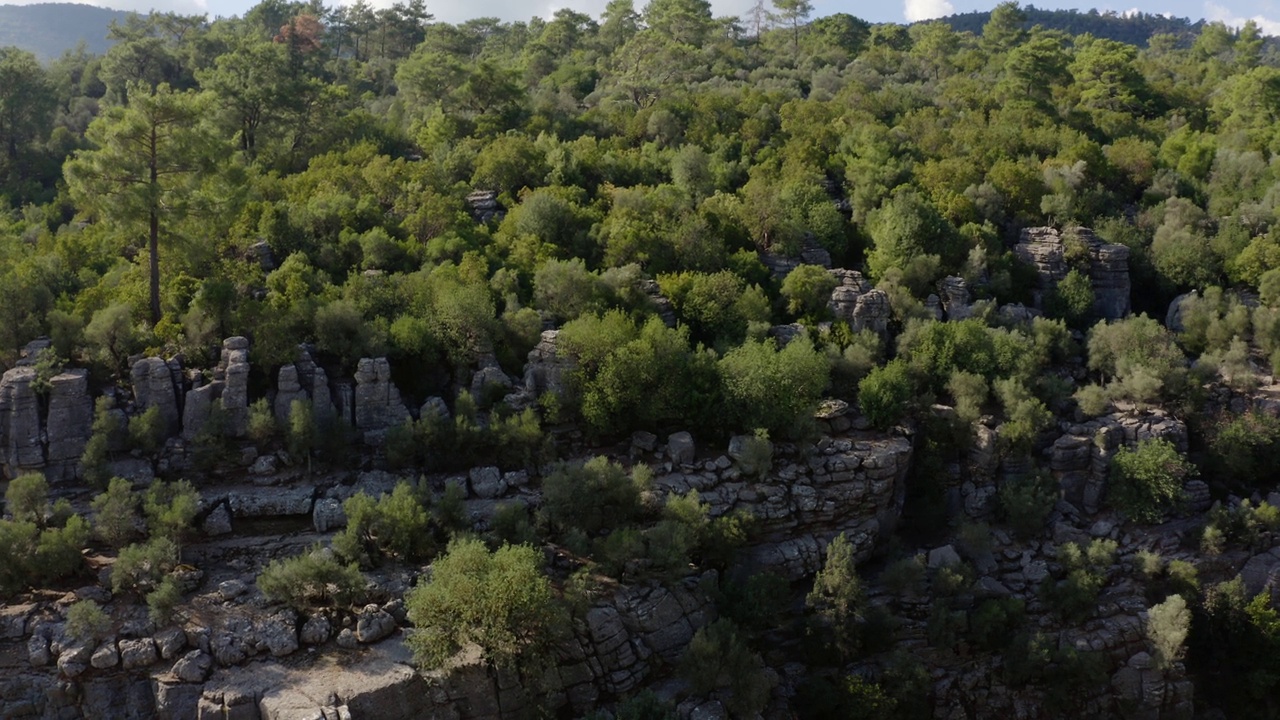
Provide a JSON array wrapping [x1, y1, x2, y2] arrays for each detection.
[[404, 538, 559, 669]]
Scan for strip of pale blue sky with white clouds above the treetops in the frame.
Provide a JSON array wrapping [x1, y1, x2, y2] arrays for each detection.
[[0, 0, 1280, 36]]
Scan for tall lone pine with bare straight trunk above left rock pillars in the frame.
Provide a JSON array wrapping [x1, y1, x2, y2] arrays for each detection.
[[64, 85, 215, 324]]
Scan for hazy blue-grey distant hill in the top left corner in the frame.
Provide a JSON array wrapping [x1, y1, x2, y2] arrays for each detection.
[[0, 3, 129, 61]]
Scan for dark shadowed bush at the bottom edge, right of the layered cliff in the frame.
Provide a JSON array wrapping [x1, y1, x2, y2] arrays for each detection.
[[680, 618, 773, 717]]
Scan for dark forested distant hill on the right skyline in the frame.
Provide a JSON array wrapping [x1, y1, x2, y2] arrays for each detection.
[[941, 5, 1204, 47]]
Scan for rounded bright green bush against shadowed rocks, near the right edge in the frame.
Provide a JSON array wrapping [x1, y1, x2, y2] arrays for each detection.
[[1107, 438, 1196, 523]]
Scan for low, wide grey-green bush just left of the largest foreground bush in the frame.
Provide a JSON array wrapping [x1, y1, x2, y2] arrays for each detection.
[[257, 544, 366, 610]]
